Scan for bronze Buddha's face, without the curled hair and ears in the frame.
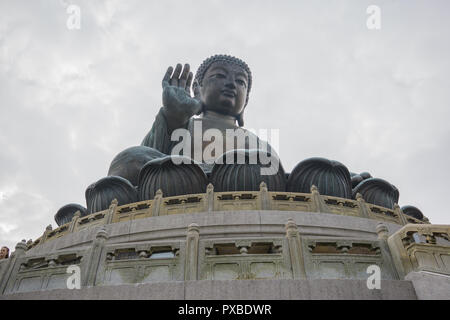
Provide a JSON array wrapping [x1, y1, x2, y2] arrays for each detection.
[[199, 62, 248, 117]]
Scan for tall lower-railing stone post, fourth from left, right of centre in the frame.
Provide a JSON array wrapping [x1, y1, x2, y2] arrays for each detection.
[[286, 219, 306, 279]]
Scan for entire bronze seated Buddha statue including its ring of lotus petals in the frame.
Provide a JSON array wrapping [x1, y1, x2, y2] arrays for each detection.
[[51, 55, 428, 224]]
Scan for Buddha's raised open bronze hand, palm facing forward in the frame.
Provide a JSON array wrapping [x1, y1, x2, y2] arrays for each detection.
[[162, 64, 202, 130]]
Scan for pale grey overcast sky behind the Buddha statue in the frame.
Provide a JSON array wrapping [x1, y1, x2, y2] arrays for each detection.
[[0, 0, 450, 250]]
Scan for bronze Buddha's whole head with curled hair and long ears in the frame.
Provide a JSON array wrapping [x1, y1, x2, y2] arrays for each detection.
[[193, 55, 252, 126]]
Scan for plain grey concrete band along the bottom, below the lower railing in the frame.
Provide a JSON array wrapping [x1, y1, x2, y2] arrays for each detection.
[[0, 279, 417, 300]]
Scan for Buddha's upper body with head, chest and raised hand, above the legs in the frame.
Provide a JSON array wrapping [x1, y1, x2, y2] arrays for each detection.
[[142, 55, 270, 163]]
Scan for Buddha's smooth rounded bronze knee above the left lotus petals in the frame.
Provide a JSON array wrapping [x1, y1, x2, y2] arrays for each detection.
[[108, 146, 165, 186]]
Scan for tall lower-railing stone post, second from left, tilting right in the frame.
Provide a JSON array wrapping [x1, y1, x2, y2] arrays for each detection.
[[82, 227, 108, 286]]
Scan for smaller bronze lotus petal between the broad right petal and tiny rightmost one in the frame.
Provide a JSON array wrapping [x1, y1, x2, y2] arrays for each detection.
[[352, 178, 399, 209]]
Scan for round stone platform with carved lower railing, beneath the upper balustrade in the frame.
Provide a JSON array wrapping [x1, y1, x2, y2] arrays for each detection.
[[0, 210, 450, 299]]
